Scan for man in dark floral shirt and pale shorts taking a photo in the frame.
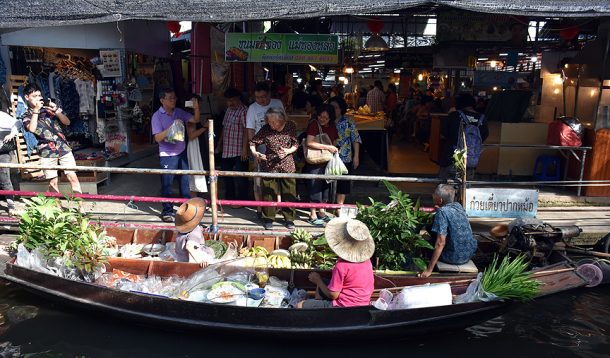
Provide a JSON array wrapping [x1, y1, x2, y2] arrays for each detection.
[[22, 83, 82, 193]]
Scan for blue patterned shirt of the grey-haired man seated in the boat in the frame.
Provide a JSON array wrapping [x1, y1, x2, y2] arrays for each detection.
[[432, 203, 477, 265]]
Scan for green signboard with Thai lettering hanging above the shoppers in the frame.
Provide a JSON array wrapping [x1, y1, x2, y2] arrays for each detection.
[[225, 32, 339, 64]]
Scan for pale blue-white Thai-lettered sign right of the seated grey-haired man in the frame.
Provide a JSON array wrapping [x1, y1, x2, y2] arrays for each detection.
[[464, 188, 538, 218]]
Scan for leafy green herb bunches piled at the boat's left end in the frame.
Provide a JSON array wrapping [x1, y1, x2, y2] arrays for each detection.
[[12, 195, 107, 274]]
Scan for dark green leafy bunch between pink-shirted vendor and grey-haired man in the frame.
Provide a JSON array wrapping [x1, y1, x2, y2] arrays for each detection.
[[356, 181, 434, 270]]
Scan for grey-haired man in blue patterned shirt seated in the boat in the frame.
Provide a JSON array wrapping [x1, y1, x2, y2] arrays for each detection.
[[419, 184, 477, 277]]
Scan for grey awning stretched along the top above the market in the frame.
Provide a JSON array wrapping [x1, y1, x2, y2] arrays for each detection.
[[0, 0, 610, 28]]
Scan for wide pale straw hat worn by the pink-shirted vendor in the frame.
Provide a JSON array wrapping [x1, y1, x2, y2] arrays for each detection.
[[324, 218, 375, 262]]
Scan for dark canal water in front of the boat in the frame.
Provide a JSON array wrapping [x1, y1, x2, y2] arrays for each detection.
[[0, 283, 610, 358]]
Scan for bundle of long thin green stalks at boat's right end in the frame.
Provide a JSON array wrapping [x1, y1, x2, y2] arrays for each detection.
[[481, 255, 541, 301]]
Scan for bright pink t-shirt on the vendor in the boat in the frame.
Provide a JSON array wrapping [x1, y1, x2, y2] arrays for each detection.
[[328, 259, 375, 307]]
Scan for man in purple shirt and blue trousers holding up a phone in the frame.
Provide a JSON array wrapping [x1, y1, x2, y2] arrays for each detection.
[[151, 88, 199, 222]]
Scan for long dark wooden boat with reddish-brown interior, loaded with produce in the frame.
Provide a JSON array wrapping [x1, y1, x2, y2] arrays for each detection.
[[2, 225, 587, 339]]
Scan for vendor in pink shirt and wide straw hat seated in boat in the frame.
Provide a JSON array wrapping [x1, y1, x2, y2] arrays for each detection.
[[297, 218, 375, 308]]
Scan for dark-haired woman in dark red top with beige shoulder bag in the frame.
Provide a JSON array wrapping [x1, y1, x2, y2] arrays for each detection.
[[303, 104, 339, 226]]
